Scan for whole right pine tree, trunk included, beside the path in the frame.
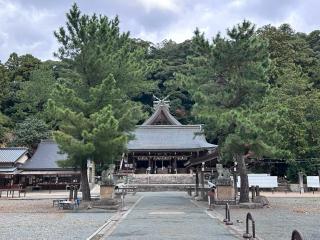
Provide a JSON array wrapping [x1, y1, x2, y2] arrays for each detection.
[[182, 21, 269, 202]]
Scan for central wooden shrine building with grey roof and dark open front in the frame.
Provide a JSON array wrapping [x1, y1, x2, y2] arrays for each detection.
[[119, 99, 217, 174]]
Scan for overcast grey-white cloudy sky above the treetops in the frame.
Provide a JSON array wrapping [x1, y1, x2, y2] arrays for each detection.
[[0, 0, 320, 62]]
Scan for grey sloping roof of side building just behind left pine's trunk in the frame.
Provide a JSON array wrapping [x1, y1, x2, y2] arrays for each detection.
[[21, 140, 67, 170]]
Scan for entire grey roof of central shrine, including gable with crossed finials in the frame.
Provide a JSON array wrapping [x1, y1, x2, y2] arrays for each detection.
[[127, 96, 217, 152]]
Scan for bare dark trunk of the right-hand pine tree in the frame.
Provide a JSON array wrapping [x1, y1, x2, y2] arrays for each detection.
[[236, 155, 249, 203]]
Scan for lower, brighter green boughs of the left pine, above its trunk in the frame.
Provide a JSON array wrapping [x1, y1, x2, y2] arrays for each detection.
[[49, 75, 143, 167]]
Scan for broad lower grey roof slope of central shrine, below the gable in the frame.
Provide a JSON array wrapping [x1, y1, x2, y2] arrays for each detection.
[[127, 125, 217, 152]]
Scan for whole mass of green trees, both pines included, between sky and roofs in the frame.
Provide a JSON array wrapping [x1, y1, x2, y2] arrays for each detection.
[[0, 5, 320, 191]]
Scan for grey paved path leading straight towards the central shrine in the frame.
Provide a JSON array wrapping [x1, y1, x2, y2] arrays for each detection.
[[105, 192, 241, 240]]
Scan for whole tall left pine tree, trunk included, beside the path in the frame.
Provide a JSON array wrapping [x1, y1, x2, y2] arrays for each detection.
[[47, 5, 146, 200]]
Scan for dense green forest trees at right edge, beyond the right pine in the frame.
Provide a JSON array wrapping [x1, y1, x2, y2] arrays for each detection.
[[259, 24, 320, 179]]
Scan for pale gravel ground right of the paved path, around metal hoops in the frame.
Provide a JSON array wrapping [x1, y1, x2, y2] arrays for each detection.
[[216, 197, 320, 240]]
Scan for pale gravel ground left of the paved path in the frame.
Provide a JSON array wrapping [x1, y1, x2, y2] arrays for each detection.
[[0, 200, 114, 240]]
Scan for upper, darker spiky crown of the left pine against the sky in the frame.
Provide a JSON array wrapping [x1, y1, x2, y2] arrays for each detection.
[[55, 4, 154, 99]]
